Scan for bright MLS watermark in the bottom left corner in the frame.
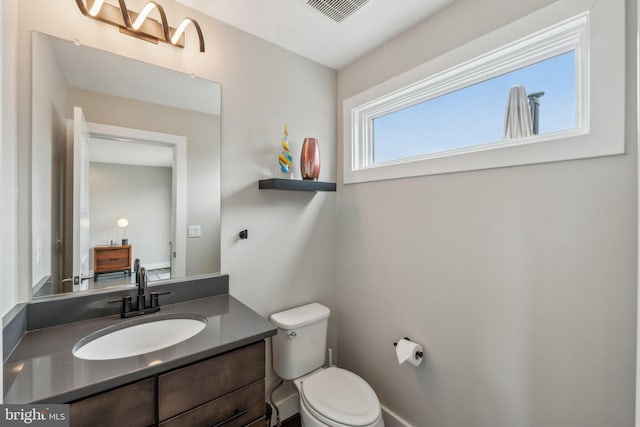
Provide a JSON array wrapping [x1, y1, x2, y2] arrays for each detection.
[[0, 405, 69, 427]]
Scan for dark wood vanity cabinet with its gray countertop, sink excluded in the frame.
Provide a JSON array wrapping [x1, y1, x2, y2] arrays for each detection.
[[4, 286, 276, 427]]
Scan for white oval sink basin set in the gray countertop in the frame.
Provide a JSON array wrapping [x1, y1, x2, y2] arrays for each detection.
[[73, 314, 207, 360]]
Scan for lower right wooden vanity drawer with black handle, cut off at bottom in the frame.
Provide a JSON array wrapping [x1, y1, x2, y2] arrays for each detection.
[[159, 380, 265, 427]]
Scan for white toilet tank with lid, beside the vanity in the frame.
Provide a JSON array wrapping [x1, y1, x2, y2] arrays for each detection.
[[269, 303, 331, 380]]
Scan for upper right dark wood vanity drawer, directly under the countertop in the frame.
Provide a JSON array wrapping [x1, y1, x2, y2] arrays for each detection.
[[158, 341, 265, 421]]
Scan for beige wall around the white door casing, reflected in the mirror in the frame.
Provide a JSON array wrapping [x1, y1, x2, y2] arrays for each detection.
[[68, 88, 220, 276]]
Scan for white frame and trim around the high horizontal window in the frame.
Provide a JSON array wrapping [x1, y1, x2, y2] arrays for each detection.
[[343, 0, 625, 184]]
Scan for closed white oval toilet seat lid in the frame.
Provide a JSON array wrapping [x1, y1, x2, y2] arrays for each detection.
[[300, 367, 381, 427]]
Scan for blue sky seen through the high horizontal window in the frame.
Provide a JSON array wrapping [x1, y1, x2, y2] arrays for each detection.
[[373, 51, 576, 163]]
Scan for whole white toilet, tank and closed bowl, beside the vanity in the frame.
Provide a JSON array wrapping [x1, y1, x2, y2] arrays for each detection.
[[269, 303, 384, 427]]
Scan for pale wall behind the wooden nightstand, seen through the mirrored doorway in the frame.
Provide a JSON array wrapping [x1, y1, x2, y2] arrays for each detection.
[[89, 162, 171, 270]]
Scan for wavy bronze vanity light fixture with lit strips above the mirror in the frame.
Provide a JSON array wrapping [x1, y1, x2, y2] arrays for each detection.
[[76, 0, 204, 52]]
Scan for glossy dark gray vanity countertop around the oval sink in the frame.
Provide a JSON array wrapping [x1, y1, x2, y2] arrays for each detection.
[[4, 294, 276, 403]]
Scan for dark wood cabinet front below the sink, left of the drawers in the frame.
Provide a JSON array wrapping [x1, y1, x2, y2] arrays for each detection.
[[69, 378, 155, 427]]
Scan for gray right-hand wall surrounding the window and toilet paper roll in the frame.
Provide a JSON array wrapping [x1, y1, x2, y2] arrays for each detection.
[[336, 0, 637, 427]]
